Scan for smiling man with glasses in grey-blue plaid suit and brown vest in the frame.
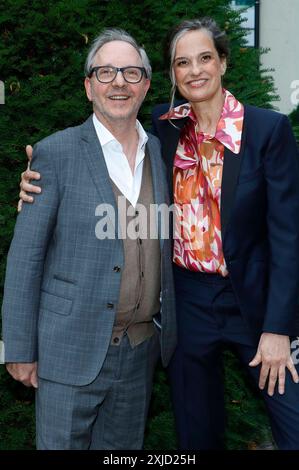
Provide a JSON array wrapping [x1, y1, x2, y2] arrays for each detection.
[[3, 29, 176, 449]]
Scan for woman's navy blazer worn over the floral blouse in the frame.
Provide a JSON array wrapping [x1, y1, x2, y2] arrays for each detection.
[[153, 105, 299, 339]]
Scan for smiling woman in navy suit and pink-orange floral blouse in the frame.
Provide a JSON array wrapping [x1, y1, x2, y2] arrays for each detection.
[[21, 18, 299, 449]]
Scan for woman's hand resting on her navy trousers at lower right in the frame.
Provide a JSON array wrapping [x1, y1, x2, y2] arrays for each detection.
[[249, 333, 299, 396]]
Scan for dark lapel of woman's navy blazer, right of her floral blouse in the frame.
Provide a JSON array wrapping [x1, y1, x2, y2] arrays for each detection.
[[220, 106, 246, 242]]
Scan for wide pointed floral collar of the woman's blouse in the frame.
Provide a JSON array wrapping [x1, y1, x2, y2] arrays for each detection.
[[159, 90, 244, 154]]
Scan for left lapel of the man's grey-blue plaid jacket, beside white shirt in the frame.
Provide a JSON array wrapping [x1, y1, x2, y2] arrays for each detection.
[[81, 116, 118, 237]]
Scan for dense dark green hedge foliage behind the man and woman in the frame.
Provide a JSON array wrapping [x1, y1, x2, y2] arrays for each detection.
[[0, 0, 276, 449]]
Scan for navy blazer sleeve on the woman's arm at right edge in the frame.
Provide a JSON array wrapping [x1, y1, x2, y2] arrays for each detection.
[[257, 115, 299, 335]]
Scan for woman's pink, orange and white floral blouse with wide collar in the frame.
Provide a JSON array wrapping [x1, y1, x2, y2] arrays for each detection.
[[160, 90, 244, 276]]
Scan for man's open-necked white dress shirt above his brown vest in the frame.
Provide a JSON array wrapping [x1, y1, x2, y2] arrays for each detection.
[[93, 114, 148, 207]]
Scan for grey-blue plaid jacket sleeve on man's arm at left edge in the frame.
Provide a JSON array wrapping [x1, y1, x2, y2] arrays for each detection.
[[2, 141, 59, 362]]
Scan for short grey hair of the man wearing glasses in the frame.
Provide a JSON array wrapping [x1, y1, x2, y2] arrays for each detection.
[[85, 28, 152, 79]]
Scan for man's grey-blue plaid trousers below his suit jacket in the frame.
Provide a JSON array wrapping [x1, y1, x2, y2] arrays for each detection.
[[36, 332, 160, 450]]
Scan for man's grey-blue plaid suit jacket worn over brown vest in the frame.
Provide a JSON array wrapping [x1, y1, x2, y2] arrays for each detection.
[[2, 117, 176, 385]]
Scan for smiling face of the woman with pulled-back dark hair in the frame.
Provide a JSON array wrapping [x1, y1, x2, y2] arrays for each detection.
[[173, 29, 226, 103]]
